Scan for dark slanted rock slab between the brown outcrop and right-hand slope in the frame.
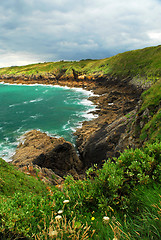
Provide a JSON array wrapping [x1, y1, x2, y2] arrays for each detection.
[[79, 117, 127, 167]]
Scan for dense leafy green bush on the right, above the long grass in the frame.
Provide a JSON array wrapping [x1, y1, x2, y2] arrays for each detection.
[[65, 142, 161, 211]]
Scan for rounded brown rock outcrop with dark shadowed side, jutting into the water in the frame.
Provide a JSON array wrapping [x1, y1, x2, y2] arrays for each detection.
[[12, 130, 82, 177]]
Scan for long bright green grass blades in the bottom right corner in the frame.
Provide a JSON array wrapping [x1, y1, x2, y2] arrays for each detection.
[[126, 184, 161, 240]]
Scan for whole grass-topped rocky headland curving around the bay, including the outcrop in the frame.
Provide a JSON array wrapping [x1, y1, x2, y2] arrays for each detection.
[[0, 46, 161, 181]]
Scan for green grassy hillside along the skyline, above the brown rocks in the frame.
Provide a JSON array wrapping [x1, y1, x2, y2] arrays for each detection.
[[0, 46, 161, 80]]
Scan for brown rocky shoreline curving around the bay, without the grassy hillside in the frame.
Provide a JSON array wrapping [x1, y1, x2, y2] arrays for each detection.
[[0, 74, 143, 184]]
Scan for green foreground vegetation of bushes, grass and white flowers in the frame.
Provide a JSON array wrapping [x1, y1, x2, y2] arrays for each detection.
[[0, 142, 161, 239]]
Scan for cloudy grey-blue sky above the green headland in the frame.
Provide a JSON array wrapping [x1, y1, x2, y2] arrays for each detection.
[[0, 0, 161, 67]]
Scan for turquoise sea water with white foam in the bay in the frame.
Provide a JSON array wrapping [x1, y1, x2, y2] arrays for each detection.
[[0, 84, 95, 161]]
